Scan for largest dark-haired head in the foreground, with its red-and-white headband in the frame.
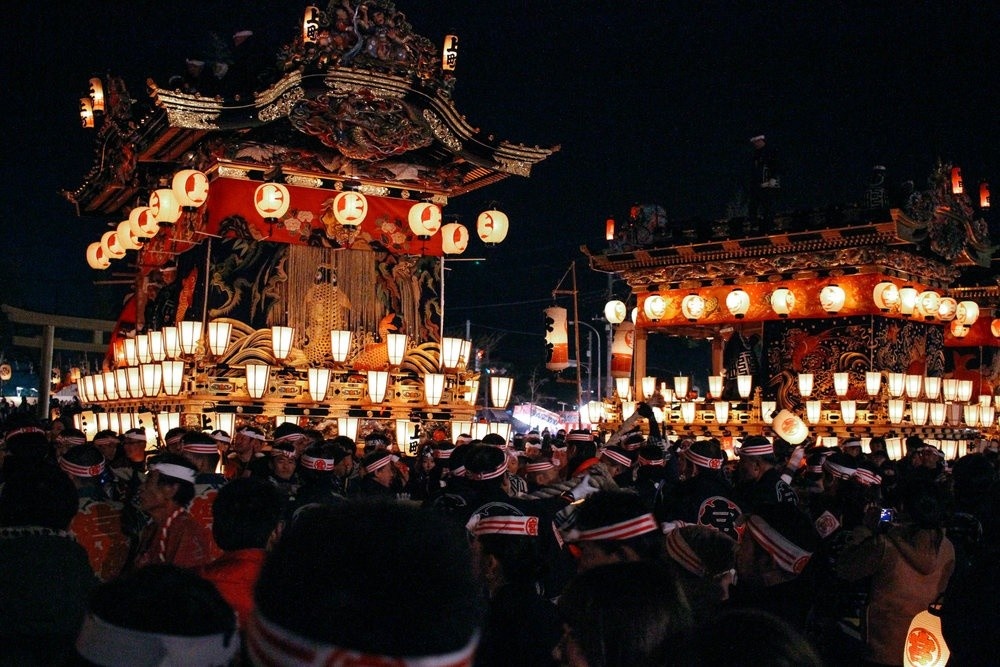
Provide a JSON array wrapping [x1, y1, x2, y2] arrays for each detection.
[[246, 500, 485, 667]]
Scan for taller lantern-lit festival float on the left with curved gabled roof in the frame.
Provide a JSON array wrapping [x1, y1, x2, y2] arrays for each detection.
[[64, 0, 558, 447]]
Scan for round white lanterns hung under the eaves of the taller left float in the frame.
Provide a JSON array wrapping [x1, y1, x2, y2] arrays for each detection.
[[87, 169, 509, 270]]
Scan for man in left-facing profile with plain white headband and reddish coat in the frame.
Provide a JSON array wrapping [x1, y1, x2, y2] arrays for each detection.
[[135, 454, 211, 567]]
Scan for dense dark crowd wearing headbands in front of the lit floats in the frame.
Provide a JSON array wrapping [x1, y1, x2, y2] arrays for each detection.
[[0, 405, 1000, 667]]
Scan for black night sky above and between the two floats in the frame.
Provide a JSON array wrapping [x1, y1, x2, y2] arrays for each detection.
[[0, 0, 1000, 392]]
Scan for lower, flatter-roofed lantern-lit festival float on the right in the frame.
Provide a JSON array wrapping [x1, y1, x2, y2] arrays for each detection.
[[582, 163, 1000, 459]]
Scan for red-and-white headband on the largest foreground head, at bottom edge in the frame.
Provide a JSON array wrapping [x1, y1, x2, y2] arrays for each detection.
[[246, 610, 479, 667]]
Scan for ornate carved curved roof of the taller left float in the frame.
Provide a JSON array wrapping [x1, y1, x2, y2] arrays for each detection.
[[64, 0, 559, 214]]
